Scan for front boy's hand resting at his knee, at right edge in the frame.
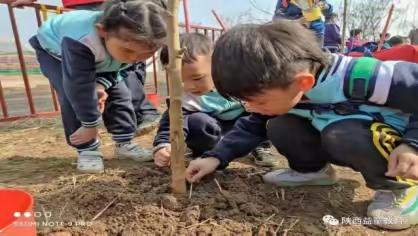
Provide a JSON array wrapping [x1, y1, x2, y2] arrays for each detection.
[[386, 144, 418, 180]]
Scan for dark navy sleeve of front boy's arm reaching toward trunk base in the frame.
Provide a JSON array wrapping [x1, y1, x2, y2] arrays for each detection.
[[203, 114, 271, 169]]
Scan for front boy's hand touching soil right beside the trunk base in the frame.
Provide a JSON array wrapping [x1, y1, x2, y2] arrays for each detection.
[[186, 157, 220, 183]]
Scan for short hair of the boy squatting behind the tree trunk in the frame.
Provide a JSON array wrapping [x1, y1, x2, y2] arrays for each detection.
[[160, 33, 213, 65]]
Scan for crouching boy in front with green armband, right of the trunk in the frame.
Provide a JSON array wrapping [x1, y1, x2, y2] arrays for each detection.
[[187, 21, 418, 229]]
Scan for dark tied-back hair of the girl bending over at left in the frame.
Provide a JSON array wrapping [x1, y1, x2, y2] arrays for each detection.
[[98, 0, 167, 45]]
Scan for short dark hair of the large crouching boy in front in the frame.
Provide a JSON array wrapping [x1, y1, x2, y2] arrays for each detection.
[[212, 20, 330, 100]]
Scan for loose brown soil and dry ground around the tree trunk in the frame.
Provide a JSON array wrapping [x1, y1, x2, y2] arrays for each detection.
[[0, 119, 418, 236]]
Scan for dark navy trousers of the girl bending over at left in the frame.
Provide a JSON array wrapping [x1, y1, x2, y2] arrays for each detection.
[[30, 37, 136, 151]]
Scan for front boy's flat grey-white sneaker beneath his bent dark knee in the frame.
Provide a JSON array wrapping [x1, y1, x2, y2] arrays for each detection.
[[263, 165, 337, 187]]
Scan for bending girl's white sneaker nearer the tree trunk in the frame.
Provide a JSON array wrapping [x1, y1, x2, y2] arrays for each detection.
[[115, 143, 152, 162]]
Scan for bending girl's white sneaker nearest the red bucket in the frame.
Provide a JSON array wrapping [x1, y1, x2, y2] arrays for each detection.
[[77, 151, 104, 173]]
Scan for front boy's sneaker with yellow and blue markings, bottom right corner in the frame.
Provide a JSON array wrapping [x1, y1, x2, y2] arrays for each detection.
[[367, 186, 418, 230]]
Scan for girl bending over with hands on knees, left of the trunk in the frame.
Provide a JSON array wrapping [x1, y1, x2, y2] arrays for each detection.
[[30, 0, 166, 172]]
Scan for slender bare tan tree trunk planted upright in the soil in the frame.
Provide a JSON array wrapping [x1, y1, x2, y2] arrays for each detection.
[[167, 0, 187, 194]]
